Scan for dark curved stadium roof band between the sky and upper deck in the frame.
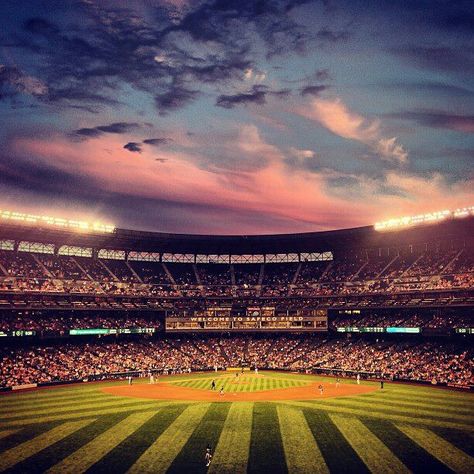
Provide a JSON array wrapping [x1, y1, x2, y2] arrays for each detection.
[[0, 217, 474, 255]]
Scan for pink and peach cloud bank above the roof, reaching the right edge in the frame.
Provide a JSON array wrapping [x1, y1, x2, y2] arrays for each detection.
[[8, 126, 474, 233]]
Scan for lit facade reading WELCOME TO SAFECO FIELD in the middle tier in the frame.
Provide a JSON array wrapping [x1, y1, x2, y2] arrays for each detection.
[[165, 306, 328, 332]]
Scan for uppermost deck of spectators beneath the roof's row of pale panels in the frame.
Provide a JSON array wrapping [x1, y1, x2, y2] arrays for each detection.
[[0, 248, 474, 297]]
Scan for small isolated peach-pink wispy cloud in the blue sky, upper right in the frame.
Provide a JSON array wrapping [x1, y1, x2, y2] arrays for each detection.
[[296, 98, 408, 163]]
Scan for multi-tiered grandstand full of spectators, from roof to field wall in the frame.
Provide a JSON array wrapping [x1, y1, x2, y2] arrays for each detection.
[[0, 212, 474, 388]]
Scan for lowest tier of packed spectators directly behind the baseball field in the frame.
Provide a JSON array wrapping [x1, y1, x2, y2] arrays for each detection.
[[0, 335, 474, 387]]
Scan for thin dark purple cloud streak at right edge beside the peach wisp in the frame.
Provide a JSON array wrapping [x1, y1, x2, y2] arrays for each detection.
[[387, 111, 474, 133]]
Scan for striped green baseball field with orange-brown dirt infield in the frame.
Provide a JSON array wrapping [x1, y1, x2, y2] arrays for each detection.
[[0, 372, 474, 474]]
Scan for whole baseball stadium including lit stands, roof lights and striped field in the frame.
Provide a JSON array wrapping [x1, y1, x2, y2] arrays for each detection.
[[0, 208, 474, 473]]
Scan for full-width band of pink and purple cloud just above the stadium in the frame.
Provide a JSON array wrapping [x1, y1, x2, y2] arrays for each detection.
[[0, 125, 474, 234]]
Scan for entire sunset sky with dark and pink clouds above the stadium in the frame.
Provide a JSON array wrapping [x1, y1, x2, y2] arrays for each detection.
[[0, 0, 474, 234]]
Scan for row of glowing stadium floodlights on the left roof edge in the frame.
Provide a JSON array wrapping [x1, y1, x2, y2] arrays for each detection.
[[0, 210, 115, 234]]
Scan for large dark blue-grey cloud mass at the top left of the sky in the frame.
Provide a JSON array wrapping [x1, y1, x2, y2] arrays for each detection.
[[1, 0, 318, 113]]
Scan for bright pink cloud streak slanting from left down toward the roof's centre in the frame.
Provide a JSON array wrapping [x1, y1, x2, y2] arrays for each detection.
[[7, 131, 366, 231]]
